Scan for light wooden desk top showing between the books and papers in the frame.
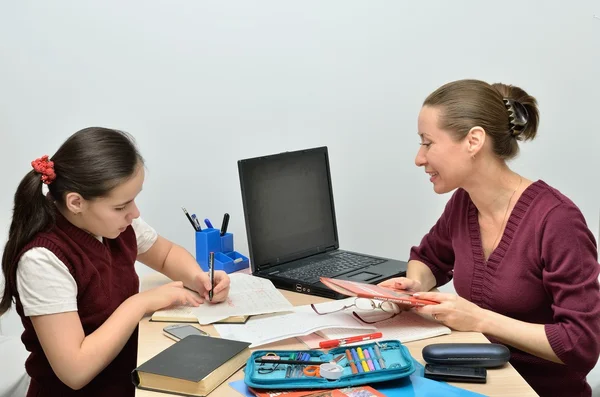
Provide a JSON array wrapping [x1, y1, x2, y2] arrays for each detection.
[[135, 273, 537, 397]]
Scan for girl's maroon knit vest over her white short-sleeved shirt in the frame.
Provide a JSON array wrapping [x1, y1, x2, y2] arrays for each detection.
[[16, 212, 139, 397]]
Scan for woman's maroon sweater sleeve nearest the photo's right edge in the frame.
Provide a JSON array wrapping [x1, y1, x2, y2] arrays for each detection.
[[541, 203, 600, 372]]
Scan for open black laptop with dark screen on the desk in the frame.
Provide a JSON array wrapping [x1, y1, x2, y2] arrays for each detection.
[[238, 147, 407, 299]]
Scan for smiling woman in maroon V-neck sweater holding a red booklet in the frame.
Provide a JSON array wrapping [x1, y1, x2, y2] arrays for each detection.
[[381, 80, 600, 396]]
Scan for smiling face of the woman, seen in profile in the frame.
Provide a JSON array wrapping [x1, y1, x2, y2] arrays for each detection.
[[415, 106, 472, 194]]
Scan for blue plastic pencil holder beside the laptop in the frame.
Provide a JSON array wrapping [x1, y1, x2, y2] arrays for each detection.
[[196, 228, 250, 273]]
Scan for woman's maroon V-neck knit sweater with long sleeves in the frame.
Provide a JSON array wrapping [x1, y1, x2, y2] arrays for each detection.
[[410, 181, 600, 397]]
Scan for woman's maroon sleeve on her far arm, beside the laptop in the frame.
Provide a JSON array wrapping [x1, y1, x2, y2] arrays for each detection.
[[410, 190, 466, 287]]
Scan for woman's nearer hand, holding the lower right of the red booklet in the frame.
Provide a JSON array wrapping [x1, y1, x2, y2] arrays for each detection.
[[413, 292, 484, 332]]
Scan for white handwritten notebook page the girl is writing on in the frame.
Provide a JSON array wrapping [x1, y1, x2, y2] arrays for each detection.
[[152, 273, 293, 325]]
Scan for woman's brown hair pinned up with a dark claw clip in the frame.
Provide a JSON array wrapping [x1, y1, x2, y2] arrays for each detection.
[[423, 80, 539, 159]]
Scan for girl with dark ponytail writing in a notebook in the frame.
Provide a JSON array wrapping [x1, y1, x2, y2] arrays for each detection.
[[0, 128, 229, 396]]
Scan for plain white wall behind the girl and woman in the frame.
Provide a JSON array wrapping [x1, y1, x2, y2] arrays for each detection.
[[0, 0, 600, 390]]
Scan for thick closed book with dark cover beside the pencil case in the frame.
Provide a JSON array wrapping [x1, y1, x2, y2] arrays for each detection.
[[132, 335, 250, 396]]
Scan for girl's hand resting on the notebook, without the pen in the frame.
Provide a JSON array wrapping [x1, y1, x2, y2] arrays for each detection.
[[137, 281, 203, 313]]
